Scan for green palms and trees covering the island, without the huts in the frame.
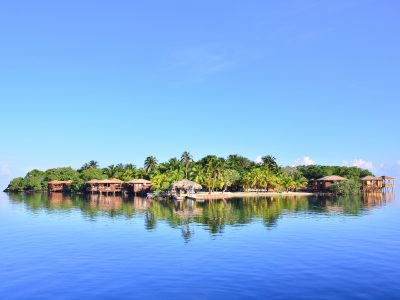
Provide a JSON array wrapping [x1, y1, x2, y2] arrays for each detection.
[[3, 151, 372, 192]]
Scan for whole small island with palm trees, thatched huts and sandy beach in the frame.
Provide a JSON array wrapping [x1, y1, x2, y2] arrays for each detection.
[[5, 152, 395, 200]]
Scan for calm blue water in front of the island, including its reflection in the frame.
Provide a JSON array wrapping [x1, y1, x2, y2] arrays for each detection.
[[0, 193, 400, 299]]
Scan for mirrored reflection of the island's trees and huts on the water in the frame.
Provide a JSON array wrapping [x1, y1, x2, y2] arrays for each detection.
[[5, 192, 395, 241]]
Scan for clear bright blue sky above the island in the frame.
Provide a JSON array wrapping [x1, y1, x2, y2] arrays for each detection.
[[0, 0, 400, 186]]
